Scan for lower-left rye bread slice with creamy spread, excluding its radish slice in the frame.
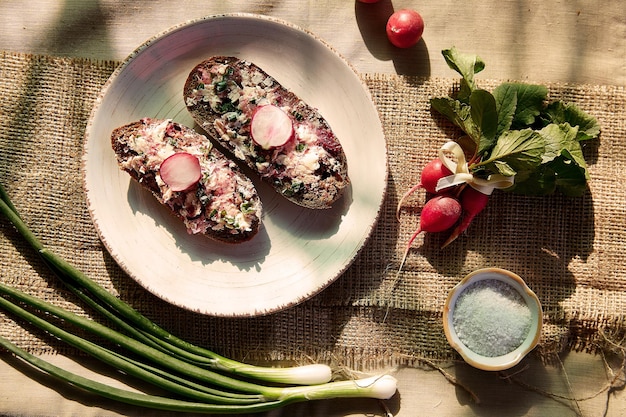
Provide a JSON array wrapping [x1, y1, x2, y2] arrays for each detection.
[[111, 118, 262, 243]]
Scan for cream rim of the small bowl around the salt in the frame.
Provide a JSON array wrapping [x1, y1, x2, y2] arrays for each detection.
[[443, 268, 543, 371]]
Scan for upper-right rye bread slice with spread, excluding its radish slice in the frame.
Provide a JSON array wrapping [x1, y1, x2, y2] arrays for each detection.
[[183, 56, 349, 209]]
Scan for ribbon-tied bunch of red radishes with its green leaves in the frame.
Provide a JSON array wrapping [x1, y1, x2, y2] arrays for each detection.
[[396, 47, 600, 272]]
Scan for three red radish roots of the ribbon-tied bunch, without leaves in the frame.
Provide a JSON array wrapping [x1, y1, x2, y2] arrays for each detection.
[[396, 154, 489, 263]]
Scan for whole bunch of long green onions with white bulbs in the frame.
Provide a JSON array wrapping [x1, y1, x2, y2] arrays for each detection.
[[0, 185, 396, 414]]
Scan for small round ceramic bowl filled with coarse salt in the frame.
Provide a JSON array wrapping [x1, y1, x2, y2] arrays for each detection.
[[443, 268, 543, 371]]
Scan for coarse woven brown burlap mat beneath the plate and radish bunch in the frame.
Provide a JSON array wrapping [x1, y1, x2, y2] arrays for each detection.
[[0, 53, 626, 369]]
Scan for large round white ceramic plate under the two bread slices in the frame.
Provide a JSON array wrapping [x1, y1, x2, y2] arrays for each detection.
[[83, 14, 387, 317]]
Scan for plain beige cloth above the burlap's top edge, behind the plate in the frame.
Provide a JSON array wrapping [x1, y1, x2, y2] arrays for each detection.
[[0, 0, 626, 85]]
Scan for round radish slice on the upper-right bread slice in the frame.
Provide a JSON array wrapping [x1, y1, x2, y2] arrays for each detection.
[[250, 104, 293, 149]]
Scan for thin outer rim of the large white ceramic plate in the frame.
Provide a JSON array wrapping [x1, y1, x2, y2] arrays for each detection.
[[81, 13, 389, 318]]
